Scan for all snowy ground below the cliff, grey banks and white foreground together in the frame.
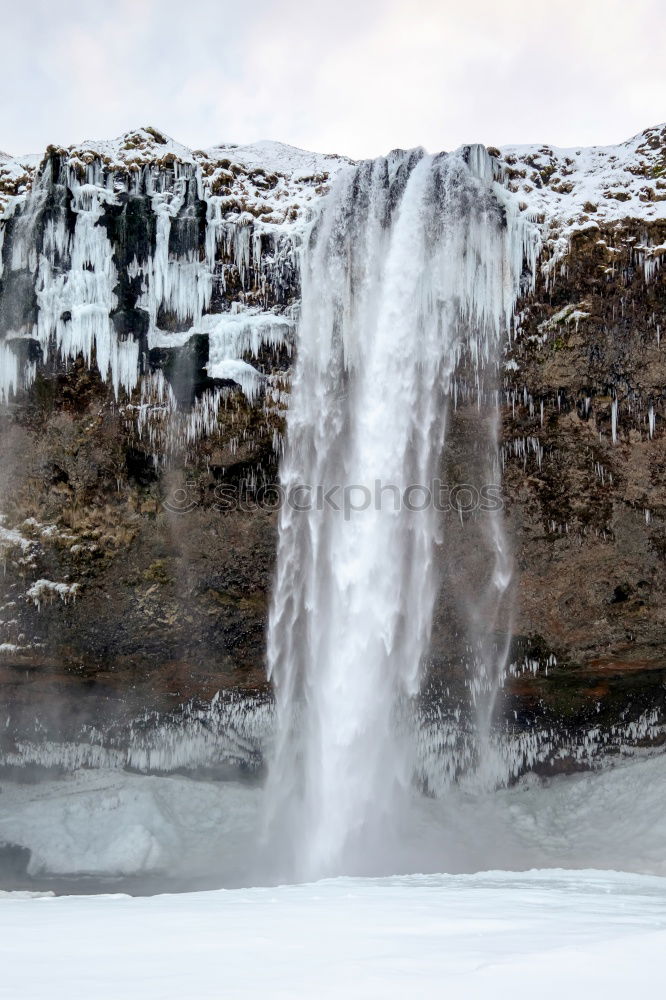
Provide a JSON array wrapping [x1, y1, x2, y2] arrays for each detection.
[[0, 708, 666, 1000]]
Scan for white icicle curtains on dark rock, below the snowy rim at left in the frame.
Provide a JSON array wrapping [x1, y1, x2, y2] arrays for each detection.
[[0, 156, 296, 423]]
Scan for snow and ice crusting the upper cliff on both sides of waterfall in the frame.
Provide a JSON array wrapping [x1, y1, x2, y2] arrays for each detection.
[[0, 126, 666, 410]]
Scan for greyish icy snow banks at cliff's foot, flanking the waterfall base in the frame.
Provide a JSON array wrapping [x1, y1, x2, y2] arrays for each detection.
[[0, 754, 666, 889]]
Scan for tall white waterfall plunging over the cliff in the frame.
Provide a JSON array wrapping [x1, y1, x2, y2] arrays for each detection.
[[267, 147, 529, 878]]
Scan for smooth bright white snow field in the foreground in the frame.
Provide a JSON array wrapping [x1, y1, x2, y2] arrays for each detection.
[[0, 871, 666, 1000]]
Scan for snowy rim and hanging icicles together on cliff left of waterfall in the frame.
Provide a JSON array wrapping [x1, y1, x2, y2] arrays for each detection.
[[0, 129, 344, 442]]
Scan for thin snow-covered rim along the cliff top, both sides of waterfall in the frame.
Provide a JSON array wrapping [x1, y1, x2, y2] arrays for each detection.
[[0, 125, 666, 244]]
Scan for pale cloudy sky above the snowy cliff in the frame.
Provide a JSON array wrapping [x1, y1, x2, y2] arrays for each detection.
[[0, 0, 666, 158]]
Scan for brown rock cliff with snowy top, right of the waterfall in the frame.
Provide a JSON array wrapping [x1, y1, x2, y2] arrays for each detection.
[[504, 128, 666, 756]]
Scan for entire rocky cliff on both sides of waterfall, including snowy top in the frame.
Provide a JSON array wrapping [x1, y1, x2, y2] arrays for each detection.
[[0, 121, 666, 768]]
